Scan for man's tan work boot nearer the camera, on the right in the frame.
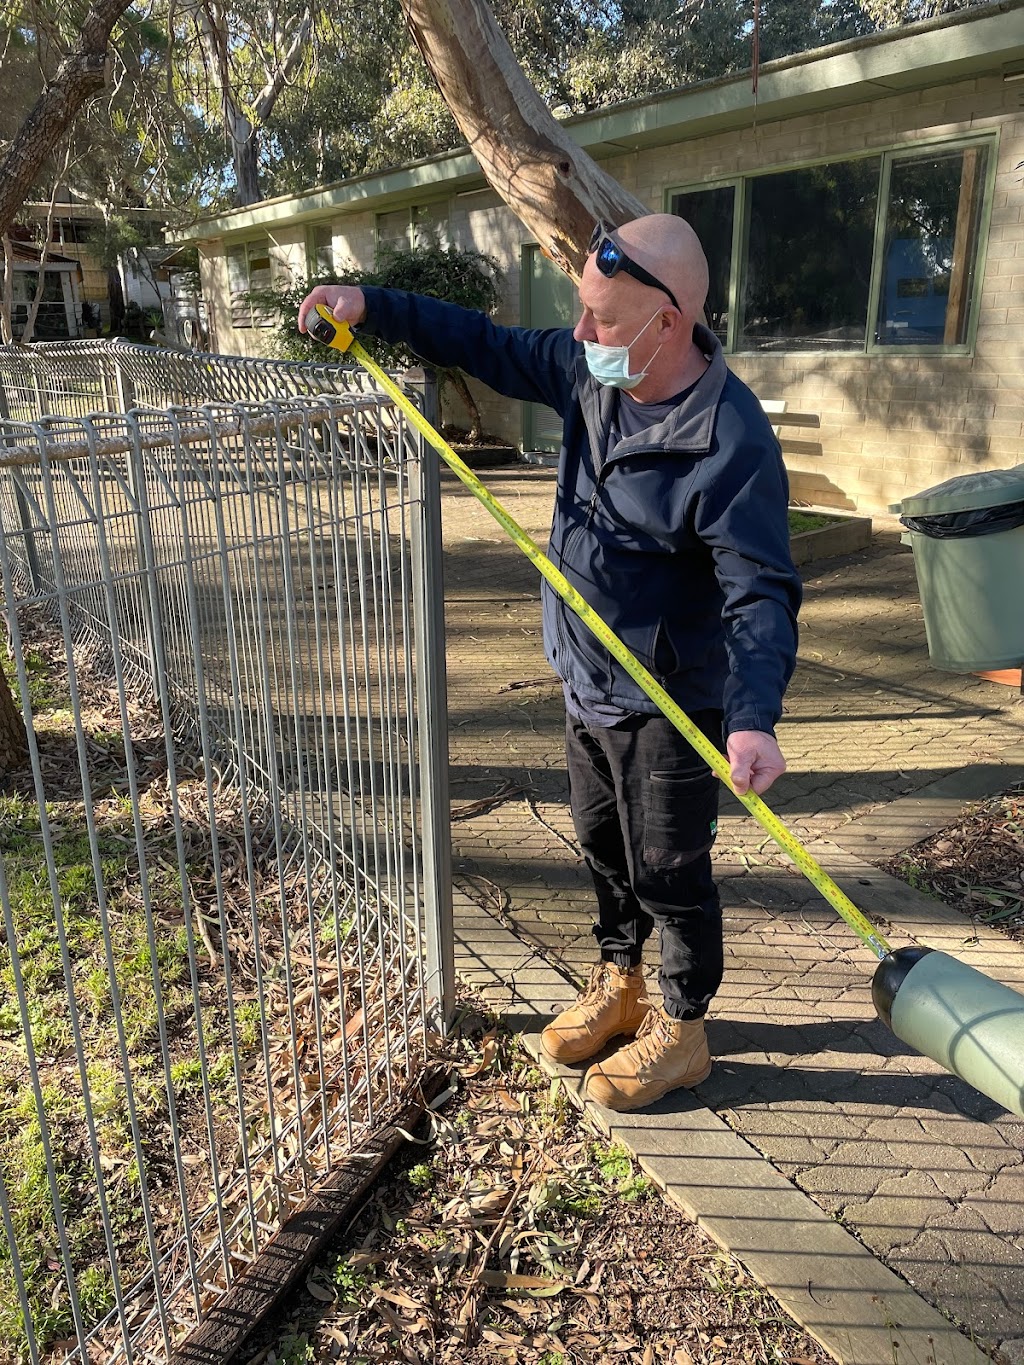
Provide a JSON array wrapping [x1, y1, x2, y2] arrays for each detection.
[[586, 1009, 711, 1111]]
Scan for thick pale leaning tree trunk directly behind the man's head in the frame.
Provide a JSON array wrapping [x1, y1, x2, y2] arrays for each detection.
[[401, 0, 650, 283]]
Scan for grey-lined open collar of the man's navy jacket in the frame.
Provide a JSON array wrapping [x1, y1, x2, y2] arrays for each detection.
[[576, 322, 729, 463]]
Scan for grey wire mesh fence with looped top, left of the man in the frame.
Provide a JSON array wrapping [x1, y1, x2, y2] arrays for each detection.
[[0, 343, 451, 1361]]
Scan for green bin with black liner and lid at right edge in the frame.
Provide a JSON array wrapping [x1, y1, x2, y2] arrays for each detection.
[[894, 464, 1024, 673]]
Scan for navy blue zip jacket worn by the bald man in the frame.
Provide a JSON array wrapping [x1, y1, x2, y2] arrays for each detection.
[[362, 288, 801, 733]]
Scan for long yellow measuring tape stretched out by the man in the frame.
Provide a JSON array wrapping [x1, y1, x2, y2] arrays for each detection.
[[306, 304, 890, 958]]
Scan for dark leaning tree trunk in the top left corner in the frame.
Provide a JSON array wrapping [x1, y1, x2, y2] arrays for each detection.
[[0, 0, 131, 235]]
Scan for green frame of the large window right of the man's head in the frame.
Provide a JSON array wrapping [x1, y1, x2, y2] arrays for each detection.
[[664, 128, 999, 356]]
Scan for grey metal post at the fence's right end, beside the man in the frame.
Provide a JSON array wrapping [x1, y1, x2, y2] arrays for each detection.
[[407, 370, 455, 1032]]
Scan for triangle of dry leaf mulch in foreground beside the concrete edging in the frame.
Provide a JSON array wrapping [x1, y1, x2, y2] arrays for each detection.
[[247, 1021, 830, 1365]]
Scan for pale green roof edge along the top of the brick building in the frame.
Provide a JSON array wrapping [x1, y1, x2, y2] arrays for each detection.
[[169, 0, 1024, 242]]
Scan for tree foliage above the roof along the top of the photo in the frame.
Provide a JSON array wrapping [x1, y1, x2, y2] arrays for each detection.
[[0, 0, 993, 229]]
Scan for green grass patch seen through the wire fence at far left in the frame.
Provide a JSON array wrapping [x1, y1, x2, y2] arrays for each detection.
[[0, 651, 236, 1361]]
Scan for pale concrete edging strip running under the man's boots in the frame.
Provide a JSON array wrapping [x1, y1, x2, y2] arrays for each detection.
[[455, 890, 989, 1365]]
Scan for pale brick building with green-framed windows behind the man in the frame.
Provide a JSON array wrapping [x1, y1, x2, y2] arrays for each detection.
[[179, 0, 1024, 511]]
